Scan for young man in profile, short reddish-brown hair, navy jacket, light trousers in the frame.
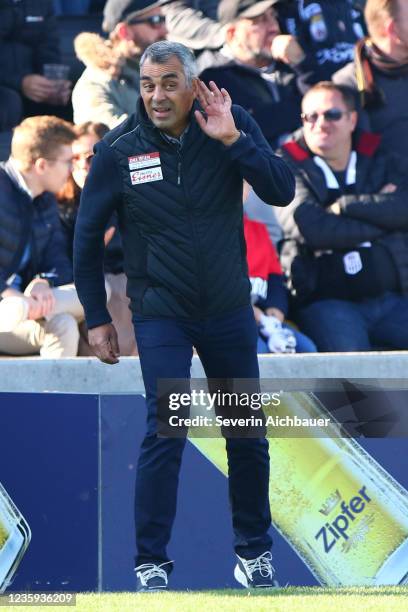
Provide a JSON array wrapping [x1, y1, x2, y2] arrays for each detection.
[[0, 116, 83, 358]]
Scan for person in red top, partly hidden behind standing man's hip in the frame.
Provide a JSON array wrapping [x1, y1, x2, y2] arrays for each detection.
[[244, 215, 316, 353]]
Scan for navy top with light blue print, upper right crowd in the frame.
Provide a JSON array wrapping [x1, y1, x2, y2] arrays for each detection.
[[289, 0, 367, 84]]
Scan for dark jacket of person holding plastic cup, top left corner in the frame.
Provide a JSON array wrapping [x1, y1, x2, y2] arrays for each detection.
[[0, 0, 60, 91]]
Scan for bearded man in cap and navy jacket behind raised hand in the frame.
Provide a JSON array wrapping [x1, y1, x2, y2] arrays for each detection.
[[198, 0, 301, 147]]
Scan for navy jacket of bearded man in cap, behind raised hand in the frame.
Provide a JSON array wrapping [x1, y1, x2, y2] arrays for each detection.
[[198, 51, 301, 147]]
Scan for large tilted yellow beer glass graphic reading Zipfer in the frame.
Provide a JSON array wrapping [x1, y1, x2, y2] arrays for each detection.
[[191, 392, 408, 586]]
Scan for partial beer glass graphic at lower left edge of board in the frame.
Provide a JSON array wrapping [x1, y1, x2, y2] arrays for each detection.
[[0, 483, 31, 593]]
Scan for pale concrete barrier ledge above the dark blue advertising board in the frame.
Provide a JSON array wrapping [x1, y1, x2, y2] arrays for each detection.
[[0, 351, 408, 393]]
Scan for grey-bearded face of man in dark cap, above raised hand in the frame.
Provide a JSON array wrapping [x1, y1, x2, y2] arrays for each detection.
[[227, 7, 280, 62]]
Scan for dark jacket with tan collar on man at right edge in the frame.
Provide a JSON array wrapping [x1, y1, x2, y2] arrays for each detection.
[[333, 43, 408, 157]]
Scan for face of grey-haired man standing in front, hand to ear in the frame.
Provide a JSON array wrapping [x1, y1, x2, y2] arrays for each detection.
[[140, 56, 197, 137]]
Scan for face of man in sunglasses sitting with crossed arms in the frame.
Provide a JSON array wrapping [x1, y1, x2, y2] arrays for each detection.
[[302, 90, 357, 160]]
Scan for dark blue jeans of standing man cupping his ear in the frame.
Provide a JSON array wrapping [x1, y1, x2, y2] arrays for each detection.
[[133, 307, 272, 565]]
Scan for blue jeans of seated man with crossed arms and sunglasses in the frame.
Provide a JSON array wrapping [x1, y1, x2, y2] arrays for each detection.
[[296, 292, 408, 352]]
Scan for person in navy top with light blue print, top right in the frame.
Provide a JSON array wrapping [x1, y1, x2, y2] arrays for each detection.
[[272, 0, 366, 90]]
